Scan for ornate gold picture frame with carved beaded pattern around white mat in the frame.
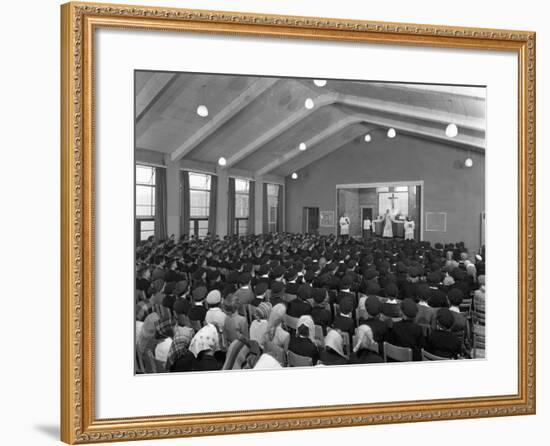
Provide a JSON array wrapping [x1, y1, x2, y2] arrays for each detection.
[[61, 3, 535, 443]]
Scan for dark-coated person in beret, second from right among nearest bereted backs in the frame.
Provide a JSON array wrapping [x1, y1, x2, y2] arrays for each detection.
[[388, 299, 425, 361]]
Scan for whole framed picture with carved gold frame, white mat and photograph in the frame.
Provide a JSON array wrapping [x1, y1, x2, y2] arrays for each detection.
[[61, 3, 535, 443]]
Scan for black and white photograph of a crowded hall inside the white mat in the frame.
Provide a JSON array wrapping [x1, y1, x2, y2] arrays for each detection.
[[134, 70, 488, 374]]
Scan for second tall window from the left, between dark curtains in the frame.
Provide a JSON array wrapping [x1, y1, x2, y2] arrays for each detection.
[[189, 172, 211, 238]]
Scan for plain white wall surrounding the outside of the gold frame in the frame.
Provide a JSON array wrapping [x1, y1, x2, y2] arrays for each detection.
[[0, 0, 550, 446]]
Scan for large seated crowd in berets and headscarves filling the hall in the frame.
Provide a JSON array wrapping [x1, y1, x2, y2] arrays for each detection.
[[135, 233, 485, 373]]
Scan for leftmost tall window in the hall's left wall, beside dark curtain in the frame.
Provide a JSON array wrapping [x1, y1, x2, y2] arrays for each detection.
[[136, 164, 155, 241]]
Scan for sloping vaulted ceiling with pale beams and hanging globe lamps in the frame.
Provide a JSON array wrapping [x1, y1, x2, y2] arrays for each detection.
[[135, 71, 485, 176]]
